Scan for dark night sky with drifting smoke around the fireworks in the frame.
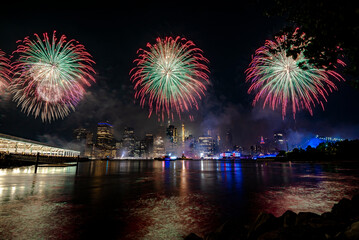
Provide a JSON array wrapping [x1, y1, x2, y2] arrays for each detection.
[[0, 1, 359, 146]]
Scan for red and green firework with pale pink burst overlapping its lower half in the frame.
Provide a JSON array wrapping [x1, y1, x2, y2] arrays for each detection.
[[10, 31, 95, 122]]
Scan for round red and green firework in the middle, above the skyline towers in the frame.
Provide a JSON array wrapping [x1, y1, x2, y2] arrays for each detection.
[[130, 37, 209, 121]]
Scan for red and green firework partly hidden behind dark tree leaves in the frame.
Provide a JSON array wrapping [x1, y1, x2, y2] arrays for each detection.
[[246, 32, 345, 118]]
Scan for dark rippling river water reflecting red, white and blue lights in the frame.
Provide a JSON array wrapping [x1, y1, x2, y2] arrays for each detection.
[[0, 160, 359, 239]]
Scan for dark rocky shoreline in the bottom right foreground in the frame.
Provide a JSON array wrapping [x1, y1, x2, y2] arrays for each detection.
[[184, 194, 359, 240]]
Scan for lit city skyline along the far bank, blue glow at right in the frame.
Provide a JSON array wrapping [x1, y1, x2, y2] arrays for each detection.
[[71, 121, 345, 159]]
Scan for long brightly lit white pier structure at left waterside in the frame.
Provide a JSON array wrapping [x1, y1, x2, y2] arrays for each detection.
[[0, 133, 80, 157]]
